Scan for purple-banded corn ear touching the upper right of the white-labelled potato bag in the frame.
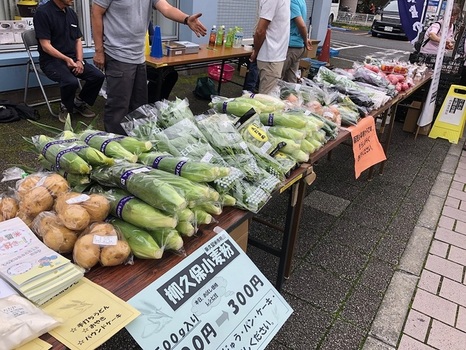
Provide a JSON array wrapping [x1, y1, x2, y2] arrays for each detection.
[[103, 188, 178, 229]]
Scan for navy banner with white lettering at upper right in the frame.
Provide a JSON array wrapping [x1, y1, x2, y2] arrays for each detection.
[[398, 0, 425, 43]]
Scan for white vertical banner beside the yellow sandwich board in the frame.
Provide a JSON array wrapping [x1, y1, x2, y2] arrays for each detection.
[[416, 0, 453, 127]]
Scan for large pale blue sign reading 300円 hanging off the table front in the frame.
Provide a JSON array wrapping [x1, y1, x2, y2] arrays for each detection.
[[126, 230, 293, 350]]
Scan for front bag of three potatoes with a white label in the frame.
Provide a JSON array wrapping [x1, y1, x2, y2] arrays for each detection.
[[73, 222, 133, 271]]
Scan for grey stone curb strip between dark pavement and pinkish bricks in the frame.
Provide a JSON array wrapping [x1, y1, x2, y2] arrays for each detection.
[[362, 139, 464, 350]]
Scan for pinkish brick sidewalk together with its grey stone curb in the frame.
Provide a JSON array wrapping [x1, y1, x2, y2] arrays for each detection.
[[363, 139, 466, 350]]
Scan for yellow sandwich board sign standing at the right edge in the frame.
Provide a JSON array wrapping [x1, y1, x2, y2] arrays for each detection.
[[429, 85, 466, 143]]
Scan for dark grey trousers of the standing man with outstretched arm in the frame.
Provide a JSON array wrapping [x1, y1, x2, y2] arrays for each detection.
[[104, 55, 147, 135]]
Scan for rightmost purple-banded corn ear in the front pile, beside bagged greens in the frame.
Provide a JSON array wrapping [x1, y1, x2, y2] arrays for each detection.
[[139, 152, 231, 182]]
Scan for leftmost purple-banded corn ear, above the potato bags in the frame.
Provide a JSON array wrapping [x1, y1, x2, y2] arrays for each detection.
[[32, 135, 91, 174]]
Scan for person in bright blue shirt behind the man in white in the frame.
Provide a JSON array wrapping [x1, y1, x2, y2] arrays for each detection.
[[282, 0, 312, 83]]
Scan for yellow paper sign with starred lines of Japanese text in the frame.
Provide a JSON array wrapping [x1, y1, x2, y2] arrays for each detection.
[[42, 278, 140, 350]]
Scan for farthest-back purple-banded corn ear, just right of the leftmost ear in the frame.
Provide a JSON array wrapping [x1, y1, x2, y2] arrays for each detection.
[[79, 130, 138, 163]]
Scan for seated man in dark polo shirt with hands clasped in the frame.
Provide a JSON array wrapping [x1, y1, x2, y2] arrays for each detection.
[[34, 0, 105, 122]]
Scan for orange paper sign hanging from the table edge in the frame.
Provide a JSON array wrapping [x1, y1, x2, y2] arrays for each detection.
[[350, 117, 387, 179]]
